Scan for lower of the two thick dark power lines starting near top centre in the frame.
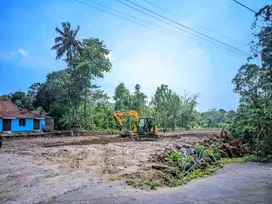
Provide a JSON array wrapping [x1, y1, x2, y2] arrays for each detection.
[[116, 0, 248, 54]]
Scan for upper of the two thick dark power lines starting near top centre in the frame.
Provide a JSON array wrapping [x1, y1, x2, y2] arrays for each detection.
[[120, 0, 249, 56]]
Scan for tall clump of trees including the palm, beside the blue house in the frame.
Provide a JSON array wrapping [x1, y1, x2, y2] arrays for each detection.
[[15, 22, 112, 130]]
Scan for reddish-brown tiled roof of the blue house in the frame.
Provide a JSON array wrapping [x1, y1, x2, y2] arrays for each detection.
[[0, 100, 44, 118]]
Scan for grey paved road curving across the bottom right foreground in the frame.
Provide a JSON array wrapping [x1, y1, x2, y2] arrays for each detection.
[[48, 163, 272, 204]]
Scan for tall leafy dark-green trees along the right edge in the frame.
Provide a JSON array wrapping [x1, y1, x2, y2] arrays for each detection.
[[228, 5, 272, 156]]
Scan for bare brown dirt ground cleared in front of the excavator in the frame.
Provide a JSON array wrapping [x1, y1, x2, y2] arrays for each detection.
[[0, 130, 220, 203]]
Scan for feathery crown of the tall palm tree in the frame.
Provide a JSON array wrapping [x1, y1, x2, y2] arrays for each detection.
[[51, 22, 82, 68]]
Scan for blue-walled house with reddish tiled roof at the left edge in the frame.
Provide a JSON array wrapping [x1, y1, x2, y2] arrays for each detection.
[[0, 100, 45, 133]]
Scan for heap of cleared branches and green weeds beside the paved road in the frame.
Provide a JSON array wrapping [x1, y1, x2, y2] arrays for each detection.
[[126, 141, 223, 189]]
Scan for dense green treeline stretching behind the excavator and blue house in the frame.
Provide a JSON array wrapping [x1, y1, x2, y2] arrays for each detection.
[[1, 80, 235, 130]]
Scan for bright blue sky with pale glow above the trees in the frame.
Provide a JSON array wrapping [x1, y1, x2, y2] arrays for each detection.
[[0, 0, 271, 111]]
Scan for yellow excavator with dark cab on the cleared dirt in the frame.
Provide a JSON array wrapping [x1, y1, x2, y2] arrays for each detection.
[[112, 110, 159, 140]]
